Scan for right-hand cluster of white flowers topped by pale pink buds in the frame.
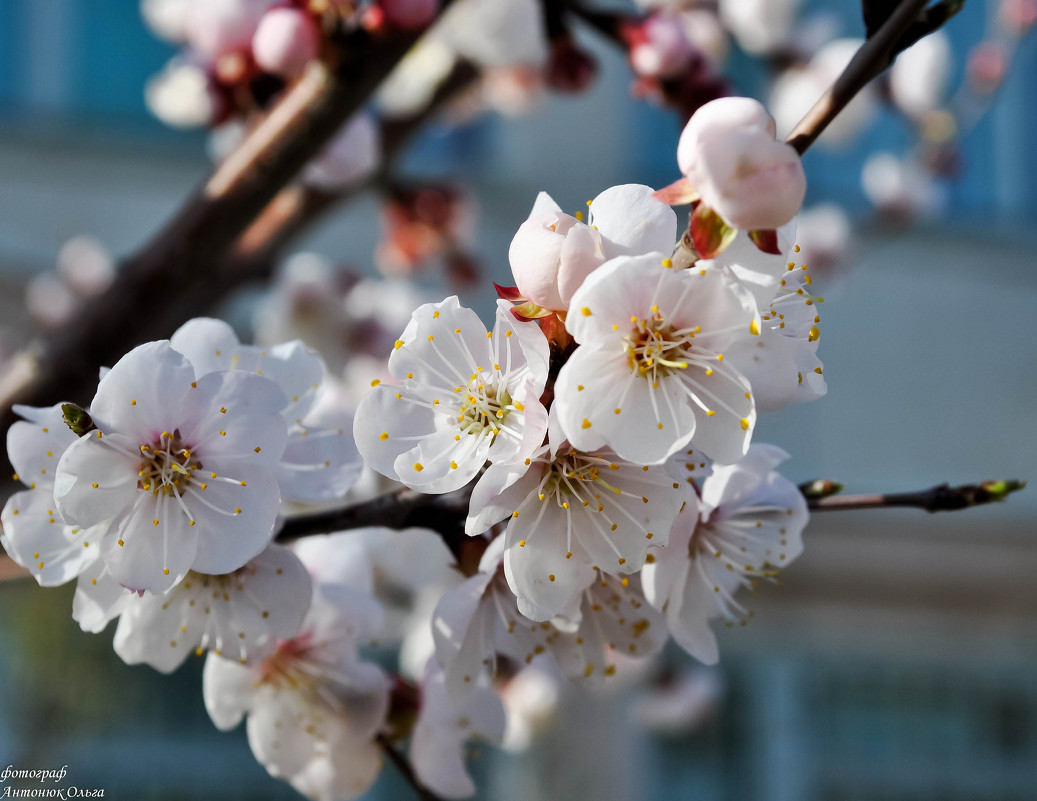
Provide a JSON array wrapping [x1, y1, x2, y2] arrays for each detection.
[[354, 93, 825, 730]]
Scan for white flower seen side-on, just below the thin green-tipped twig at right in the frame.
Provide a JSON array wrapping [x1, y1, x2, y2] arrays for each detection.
[[641, 444, 809, 664]]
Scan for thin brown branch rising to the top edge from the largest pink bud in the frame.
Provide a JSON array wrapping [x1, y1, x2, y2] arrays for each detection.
[[785, 0, 929, 156]]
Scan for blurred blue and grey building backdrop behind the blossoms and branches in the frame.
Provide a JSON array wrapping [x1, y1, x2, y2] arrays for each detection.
[[0, 0, 1037, 801]]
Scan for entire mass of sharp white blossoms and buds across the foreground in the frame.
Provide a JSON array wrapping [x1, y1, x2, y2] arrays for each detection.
[[0, 99, 825, 799]]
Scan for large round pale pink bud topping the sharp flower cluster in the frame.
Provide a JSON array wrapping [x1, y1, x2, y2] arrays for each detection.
[[677, 98, 807, 230]]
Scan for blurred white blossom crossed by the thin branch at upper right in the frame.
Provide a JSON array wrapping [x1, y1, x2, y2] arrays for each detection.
[[771, 37, 878, 146]]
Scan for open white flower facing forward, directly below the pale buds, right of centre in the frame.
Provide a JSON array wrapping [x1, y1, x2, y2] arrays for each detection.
[[555, 253, 760, 462]]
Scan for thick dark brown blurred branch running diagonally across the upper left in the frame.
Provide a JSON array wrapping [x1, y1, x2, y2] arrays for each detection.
[[0, 0, 451, 437]]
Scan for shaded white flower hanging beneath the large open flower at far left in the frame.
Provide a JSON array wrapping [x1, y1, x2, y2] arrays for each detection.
[[73, 544, 311, 673]]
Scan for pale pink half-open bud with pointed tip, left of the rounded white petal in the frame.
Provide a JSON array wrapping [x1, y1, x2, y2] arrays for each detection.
[[508, 212, 605, 311]]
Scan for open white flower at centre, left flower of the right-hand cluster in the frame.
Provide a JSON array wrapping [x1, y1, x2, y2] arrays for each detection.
[[354, 297, 549, 493]]
